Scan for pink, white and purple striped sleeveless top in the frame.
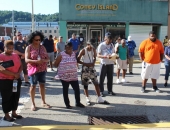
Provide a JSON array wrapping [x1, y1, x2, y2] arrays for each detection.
[[58, 51, 78, 82]]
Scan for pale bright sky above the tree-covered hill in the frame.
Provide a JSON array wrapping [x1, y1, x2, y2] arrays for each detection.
[[0, 0, 59, 14]]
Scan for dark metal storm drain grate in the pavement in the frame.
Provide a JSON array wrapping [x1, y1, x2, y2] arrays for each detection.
[[88, 116, 150, 125]]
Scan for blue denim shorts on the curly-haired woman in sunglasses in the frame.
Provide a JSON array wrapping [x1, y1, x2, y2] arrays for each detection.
[[30, 71, 46, 86]]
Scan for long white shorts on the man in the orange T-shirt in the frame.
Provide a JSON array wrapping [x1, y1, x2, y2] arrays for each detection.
[[141, 61, 161, 80]]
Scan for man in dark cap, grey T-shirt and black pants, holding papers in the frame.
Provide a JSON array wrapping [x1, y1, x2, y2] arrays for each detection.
[[97, 32, 115, 96]]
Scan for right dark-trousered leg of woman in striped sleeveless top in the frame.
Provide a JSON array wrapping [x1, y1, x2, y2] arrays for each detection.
[[70, 80, 80, 105]]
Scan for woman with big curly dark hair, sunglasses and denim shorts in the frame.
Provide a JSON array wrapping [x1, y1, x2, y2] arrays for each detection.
[[25, 31, 50, 111]]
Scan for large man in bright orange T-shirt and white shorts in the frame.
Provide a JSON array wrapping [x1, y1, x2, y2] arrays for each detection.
[[138, 31, 164, 93]]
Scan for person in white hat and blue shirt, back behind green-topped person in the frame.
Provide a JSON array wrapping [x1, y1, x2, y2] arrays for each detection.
[[126, 36, 136, 74]]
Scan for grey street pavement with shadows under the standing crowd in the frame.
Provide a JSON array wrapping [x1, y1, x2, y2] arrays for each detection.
[[0, 63, 170, 130]]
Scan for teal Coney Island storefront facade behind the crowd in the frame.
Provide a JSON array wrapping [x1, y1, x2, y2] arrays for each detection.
[[59, 0, 168, 53]]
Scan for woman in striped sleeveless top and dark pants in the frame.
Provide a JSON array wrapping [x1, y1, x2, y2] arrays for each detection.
[[54, 42, 84, 109]]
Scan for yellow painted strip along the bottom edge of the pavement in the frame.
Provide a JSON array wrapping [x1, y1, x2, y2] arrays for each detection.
[[0, 122, 170, 130]]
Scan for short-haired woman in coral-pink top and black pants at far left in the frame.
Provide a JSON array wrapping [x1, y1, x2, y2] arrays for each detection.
[[0, 40, 22, 122]]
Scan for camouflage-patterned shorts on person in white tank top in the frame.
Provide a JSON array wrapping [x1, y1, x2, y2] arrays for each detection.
[[81, 66, 99, 86]]
